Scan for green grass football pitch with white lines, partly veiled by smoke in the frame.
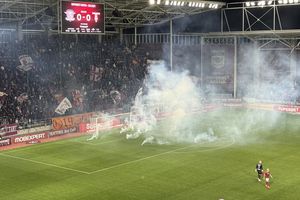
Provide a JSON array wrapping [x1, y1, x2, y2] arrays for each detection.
[[0, 109, 300, 200]]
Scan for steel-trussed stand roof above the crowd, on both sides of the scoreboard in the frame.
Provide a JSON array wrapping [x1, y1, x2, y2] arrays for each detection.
[[0, 0, 225, 29]]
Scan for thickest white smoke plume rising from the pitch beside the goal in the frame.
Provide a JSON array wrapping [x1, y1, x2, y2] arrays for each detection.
[[121, 62, 217, 145]]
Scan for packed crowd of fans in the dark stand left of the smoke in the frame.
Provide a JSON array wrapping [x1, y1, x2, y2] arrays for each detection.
[[0, 36, 149, 124]]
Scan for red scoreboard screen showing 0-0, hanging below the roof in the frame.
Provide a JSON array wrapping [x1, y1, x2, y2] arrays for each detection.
[[61, 1, 105, 34]]
